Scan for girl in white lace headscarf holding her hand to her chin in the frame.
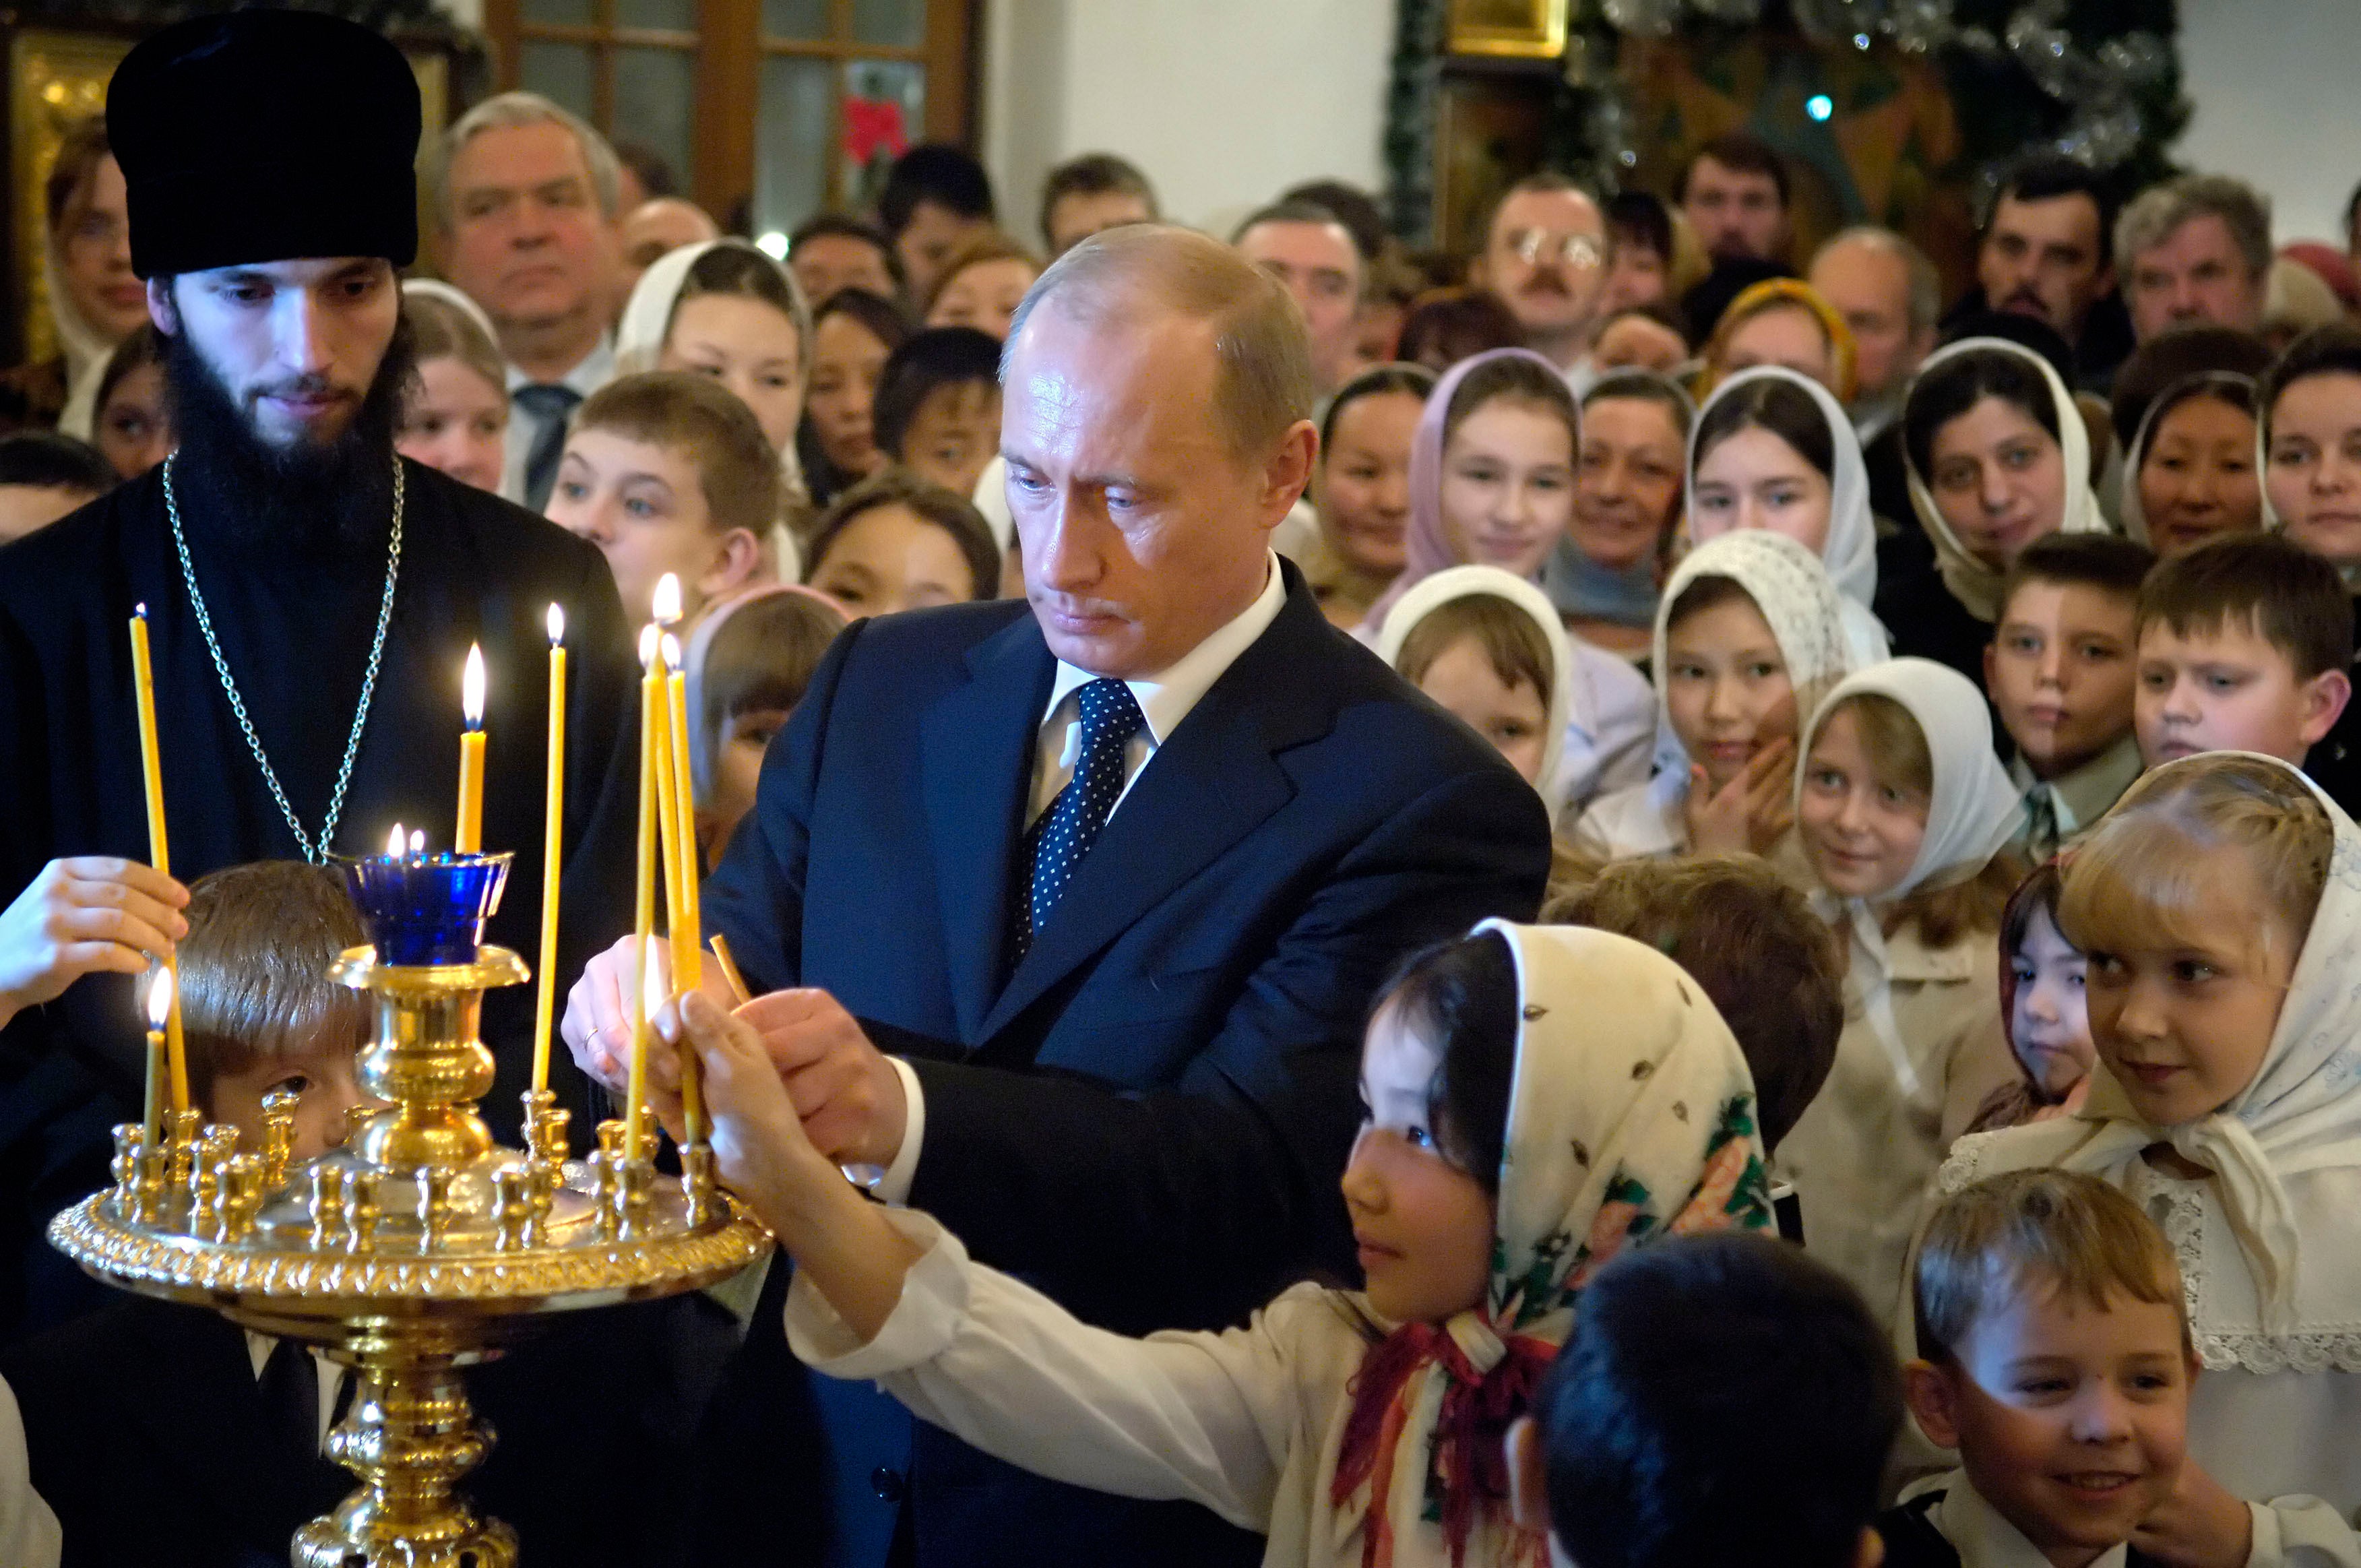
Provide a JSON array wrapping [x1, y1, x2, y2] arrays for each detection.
[[1575, 529, 1851, 864]]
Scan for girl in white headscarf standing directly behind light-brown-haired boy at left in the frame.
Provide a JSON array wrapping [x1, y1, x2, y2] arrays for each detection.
[[614, 239, 812, 581]]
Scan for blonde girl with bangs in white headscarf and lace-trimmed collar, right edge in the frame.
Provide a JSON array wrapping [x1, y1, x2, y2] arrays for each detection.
[[1941, 751, 2361, 1561]]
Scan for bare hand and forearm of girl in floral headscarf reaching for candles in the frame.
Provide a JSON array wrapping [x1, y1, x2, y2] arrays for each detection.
[[656, 992, 921, 1342]]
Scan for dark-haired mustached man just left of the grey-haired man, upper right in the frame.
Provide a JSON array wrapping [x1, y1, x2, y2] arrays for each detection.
[[1953, 156, 2132, 389]]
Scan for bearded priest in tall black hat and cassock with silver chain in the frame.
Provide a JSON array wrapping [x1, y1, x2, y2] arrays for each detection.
[[0, 9, 633, 1339]]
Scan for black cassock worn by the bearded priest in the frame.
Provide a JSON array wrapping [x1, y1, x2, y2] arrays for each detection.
[[0, 460, 637, 1342]]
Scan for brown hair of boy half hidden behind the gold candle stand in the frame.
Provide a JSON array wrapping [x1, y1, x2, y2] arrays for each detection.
[[179, 860, 369, 1103]]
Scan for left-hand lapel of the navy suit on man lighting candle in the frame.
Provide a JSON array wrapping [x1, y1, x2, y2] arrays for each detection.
[[918, 614, 1058, 1046]]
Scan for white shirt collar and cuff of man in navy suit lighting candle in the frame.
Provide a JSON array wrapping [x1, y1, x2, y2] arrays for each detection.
[[873, 551, 1287, 1204]]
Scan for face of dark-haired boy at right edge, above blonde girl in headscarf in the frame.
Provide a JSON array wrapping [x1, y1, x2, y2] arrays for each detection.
[[2132, 617, 2352, 767]]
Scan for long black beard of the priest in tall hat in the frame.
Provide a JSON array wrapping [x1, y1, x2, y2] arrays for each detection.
[[163, 312, 418, 553]]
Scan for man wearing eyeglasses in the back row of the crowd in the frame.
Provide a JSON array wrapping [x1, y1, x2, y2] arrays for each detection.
[[1471, 173, 1610, 392]]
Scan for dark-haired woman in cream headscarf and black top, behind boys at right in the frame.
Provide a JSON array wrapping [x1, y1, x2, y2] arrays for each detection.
[[1879, 338, 2108, 680]]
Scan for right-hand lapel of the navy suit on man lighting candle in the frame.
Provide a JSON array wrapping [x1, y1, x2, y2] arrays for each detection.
[[968, 569, 1334, 1046]]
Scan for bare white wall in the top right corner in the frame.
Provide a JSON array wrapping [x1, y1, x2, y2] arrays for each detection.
[[2172, 0, 2361, 248]]
